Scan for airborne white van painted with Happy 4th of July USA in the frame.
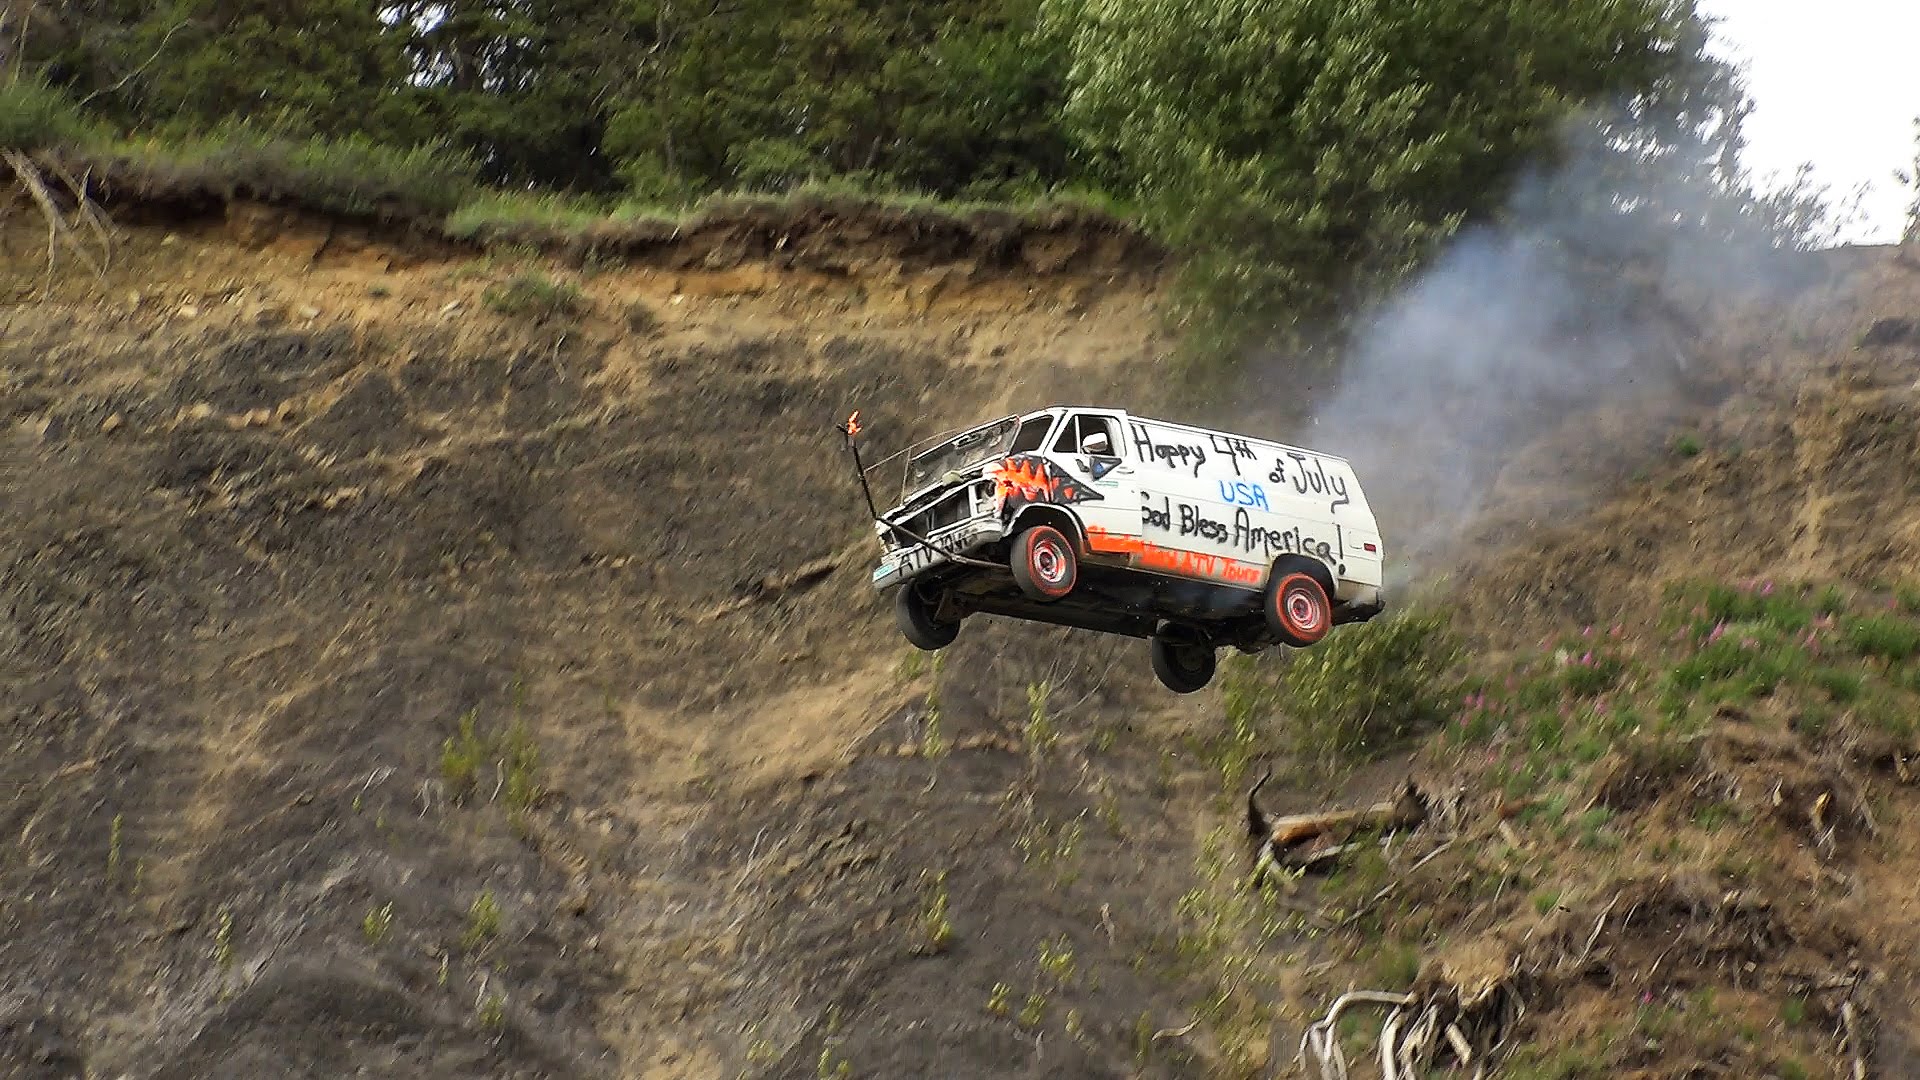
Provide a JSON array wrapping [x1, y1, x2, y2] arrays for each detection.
[[841, 405, 1384, 694]]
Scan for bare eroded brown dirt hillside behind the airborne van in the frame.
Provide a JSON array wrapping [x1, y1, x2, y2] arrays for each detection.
[[0, 193, 1920, 1078]]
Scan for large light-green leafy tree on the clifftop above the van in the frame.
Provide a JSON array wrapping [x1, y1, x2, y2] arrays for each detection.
[[1044, 0, 1751, 363]]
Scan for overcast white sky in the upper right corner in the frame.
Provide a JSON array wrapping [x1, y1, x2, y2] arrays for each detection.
[[1699, 0, 1920, 244]]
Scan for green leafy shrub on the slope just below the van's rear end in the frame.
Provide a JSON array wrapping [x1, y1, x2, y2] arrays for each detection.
[[1281, 611, 1461, 759]]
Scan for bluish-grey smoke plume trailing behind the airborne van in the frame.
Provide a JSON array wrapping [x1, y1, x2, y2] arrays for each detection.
[[1261, 116, 1835, 584]]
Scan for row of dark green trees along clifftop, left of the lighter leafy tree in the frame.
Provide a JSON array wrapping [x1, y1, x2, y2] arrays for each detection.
[[18, 0, 1075, 198]]
